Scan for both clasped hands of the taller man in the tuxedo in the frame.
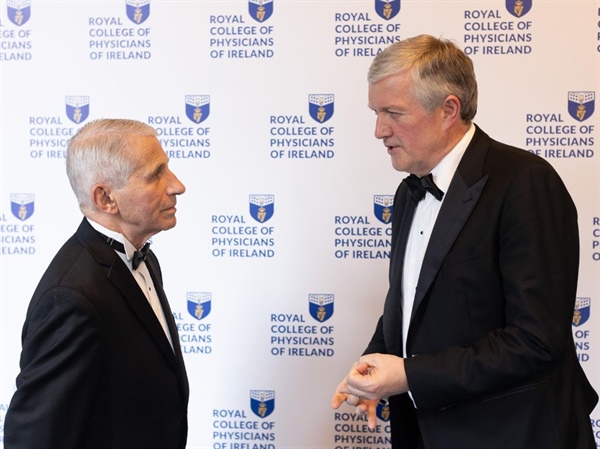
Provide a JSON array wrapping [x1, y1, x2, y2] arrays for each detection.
[[331, 354, 408, 429]]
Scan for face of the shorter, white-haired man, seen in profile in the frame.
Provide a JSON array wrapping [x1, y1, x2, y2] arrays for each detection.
[[113, 136, 185, 247]]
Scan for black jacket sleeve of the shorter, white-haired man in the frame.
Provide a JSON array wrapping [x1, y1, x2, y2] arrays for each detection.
[[4, 287, 99, 449]]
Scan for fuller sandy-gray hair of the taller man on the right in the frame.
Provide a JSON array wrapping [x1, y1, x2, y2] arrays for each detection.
[[367, 34, 477, 123]]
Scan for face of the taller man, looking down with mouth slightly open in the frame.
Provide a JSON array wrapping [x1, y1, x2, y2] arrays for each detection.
[[369, 73, 446, 176]]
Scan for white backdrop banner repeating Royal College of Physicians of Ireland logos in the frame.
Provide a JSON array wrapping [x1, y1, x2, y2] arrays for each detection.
[[0, 0, 600, 449]]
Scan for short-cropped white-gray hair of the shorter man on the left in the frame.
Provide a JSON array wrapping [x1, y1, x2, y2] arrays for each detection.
[[67, 119, 156, 212]]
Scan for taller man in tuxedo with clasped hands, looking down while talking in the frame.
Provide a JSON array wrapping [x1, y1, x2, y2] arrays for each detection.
[[332, 35, 598, 449]]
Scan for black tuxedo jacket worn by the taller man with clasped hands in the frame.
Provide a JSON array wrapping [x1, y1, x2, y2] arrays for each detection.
[[365, 129, 598, 449]]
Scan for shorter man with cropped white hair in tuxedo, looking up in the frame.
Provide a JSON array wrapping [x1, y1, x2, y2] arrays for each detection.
[[4, 119, 189, 449]]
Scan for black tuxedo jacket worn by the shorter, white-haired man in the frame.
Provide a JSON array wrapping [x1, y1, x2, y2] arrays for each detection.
[[4, 219, 189, 449]]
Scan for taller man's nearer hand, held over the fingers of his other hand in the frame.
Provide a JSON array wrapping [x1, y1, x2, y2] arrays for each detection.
[[339, 354, 408, 400]]
